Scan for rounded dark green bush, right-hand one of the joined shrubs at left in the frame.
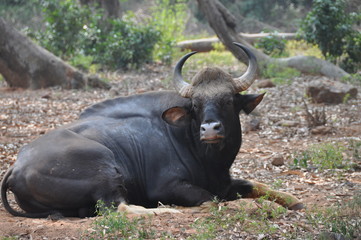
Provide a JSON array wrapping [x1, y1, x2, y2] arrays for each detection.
[[84, 13, 160, 69]]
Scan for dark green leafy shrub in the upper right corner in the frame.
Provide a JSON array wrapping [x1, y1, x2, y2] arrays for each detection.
[[301, 0, 361, 72]]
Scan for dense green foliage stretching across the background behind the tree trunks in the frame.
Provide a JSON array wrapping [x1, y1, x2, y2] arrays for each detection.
[[0, 0, 361, 73]]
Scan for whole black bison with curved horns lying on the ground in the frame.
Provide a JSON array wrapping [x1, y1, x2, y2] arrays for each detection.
[[1, 43, 302, 217]]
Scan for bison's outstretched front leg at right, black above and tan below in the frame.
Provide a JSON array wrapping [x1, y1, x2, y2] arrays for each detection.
[[228, 180, 304, 210]]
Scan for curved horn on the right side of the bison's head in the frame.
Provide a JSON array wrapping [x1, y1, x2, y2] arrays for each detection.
[[233, 42, 257, 92]]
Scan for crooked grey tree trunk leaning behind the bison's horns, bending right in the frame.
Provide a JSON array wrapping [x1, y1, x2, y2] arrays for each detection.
[[197, 0, 349, 79]]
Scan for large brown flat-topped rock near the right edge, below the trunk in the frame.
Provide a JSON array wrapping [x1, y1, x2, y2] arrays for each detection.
[[306, 79, 357, 104]]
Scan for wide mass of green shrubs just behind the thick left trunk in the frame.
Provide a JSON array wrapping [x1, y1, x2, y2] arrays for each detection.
[[35, 0, 160, 69]]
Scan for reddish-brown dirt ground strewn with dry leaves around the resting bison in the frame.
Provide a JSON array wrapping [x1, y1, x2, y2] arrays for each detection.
[[0, 70, 361, 239]]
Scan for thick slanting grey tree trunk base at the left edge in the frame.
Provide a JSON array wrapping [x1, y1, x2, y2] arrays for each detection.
[[0, 18, 109, 89]]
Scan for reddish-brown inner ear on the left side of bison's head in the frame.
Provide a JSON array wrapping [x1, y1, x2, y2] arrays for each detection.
[[162, 107, 191, 127]]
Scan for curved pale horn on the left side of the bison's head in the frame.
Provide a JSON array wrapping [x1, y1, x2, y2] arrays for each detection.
[[173, 52, 197, 98]]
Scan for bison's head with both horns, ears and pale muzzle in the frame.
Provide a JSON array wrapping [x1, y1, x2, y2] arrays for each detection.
[[163, 43, 263, 144]]
